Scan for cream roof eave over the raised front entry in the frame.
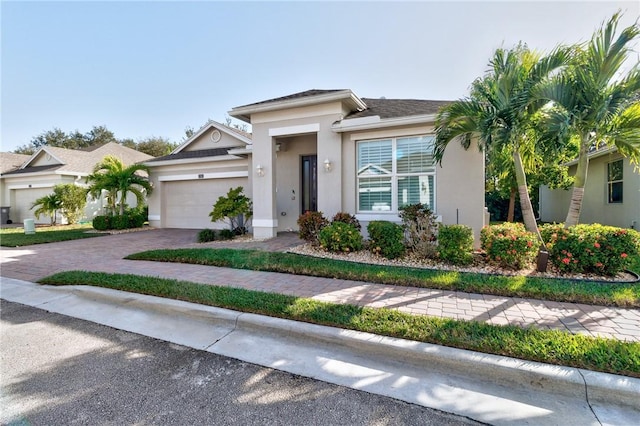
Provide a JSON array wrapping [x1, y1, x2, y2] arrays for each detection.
[[228, 90, 367, 123]]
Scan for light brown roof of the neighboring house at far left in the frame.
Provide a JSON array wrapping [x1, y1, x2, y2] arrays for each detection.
[[3, 142, 153, 176]]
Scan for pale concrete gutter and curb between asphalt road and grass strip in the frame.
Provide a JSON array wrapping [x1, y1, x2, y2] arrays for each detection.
[[0, 278, 640, 425]]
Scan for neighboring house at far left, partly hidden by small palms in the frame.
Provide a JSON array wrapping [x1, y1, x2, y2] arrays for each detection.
[[0, 142, 153, 223]]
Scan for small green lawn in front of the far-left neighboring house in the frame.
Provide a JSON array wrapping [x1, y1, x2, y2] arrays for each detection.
[[0, 224, 104, 247]]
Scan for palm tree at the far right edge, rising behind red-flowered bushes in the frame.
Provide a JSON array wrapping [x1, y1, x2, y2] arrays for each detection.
[[536, 13, 640, 227]]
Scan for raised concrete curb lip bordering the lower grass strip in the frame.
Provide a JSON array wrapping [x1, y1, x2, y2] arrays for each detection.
[[57, 286, 640, 407]]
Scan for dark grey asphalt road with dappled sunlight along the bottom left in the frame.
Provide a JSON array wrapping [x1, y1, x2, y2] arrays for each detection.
[[0, 301, 479, 426]]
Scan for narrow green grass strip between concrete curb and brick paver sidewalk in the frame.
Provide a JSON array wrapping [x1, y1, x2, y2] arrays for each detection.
[[40, 271, 640, 377]]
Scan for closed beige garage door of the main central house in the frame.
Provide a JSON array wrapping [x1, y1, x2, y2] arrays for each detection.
[[162, 178, 247, 229]]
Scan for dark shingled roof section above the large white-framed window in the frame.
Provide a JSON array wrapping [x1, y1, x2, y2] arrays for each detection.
[[344, 98, 451, 120]]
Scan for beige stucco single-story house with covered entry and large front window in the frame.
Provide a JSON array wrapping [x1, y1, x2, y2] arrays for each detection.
[[145, 90, 484, 242]]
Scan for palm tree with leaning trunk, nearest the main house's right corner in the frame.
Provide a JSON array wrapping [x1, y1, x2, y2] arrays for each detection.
[[434, 45, 570, 241]]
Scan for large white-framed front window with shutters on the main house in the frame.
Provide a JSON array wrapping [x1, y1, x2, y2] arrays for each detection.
[[357, 135, 435, 213]]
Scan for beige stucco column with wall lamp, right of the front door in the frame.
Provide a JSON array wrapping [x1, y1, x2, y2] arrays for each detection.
[[317, 125, 342, 219]]
